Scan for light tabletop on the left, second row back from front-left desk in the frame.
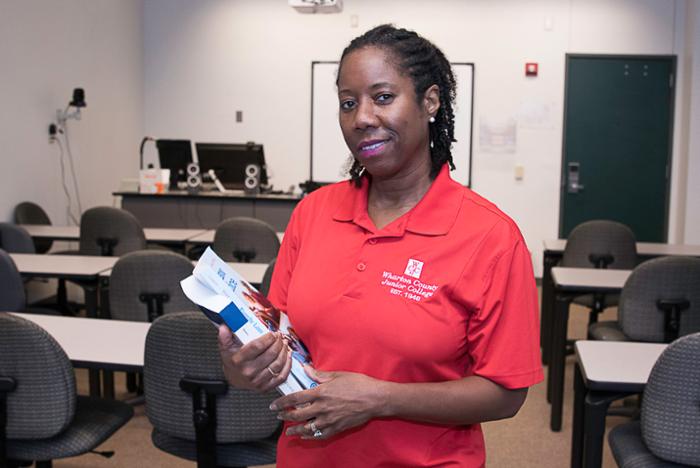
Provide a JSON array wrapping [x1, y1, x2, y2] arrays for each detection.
[[10, 254, 119, 278]]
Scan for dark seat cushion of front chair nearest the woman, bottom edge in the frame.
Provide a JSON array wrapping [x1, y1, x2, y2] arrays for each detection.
[[151, 429, 279, 466]]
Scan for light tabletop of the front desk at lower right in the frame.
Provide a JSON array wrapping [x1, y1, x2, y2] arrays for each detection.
[[574, 340, 668, 392]]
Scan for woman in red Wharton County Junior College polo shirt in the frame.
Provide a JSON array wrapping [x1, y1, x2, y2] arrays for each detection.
[[219, 25, 542, 467]]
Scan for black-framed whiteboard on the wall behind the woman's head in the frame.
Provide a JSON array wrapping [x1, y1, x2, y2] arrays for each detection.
[[309, 61, 474, 186]]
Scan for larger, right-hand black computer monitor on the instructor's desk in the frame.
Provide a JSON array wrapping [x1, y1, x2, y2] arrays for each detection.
[[195, 143, 267, 190]]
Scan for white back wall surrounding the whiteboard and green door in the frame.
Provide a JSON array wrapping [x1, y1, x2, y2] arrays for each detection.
[[144, 0, 700, 271]]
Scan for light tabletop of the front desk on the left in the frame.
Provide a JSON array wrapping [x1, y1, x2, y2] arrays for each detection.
[[8, 312, 151, 371]]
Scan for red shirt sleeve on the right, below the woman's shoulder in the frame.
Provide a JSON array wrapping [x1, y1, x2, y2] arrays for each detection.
[[467, 227, 544, 389]]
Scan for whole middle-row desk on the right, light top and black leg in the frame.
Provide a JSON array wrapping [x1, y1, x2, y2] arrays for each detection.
[[547, 267, 632, 431]]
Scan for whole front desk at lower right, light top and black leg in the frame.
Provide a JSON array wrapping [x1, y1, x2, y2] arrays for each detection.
[[571, 341, 667, 468]]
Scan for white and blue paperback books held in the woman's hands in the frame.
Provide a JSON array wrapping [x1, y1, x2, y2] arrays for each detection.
[[180, 248, 316, 395]]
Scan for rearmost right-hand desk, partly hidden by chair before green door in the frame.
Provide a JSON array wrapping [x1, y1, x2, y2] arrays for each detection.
[[540, 239, 700, 365]]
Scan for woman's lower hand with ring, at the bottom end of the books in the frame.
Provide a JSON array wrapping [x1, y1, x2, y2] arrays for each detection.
[[270, 366, 385, 439]]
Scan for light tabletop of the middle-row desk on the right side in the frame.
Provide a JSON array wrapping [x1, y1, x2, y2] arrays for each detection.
[[552, 267, 632, 292]]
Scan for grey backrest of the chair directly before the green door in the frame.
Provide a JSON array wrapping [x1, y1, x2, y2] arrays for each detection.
[[561, 220, 637, 270]]
